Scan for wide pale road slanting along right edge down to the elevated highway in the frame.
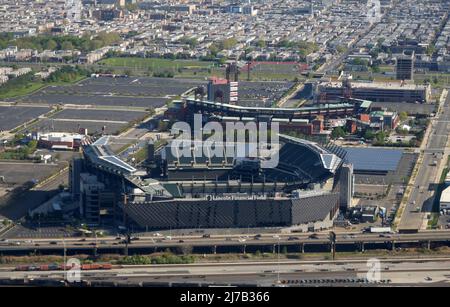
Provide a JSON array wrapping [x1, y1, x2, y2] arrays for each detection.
[[398, 91, 450, 230]]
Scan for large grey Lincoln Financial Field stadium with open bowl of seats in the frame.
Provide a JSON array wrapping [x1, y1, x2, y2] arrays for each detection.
[[71, 135, 353, 231]]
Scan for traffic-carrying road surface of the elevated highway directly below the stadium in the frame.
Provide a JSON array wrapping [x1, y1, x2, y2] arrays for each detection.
[[0, 231, 450, 252]]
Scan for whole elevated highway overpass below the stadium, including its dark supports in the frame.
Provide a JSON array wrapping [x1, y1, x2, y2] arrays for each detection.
[[0, 231, 450, 255]]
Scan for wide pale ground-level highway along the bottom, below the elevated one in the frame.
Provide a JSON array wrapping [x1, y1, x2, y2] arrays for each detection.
[[0, 258, 450, 286]]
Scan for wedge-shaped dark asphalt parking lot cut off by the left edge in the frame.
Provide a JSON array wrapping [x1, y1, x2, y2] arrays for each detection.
[[0, 106, 51, 131]]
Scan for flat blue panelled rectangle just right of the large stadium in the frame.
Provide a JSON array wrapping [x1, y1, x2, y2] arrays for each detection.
[[344, 147, 403, 172]]
